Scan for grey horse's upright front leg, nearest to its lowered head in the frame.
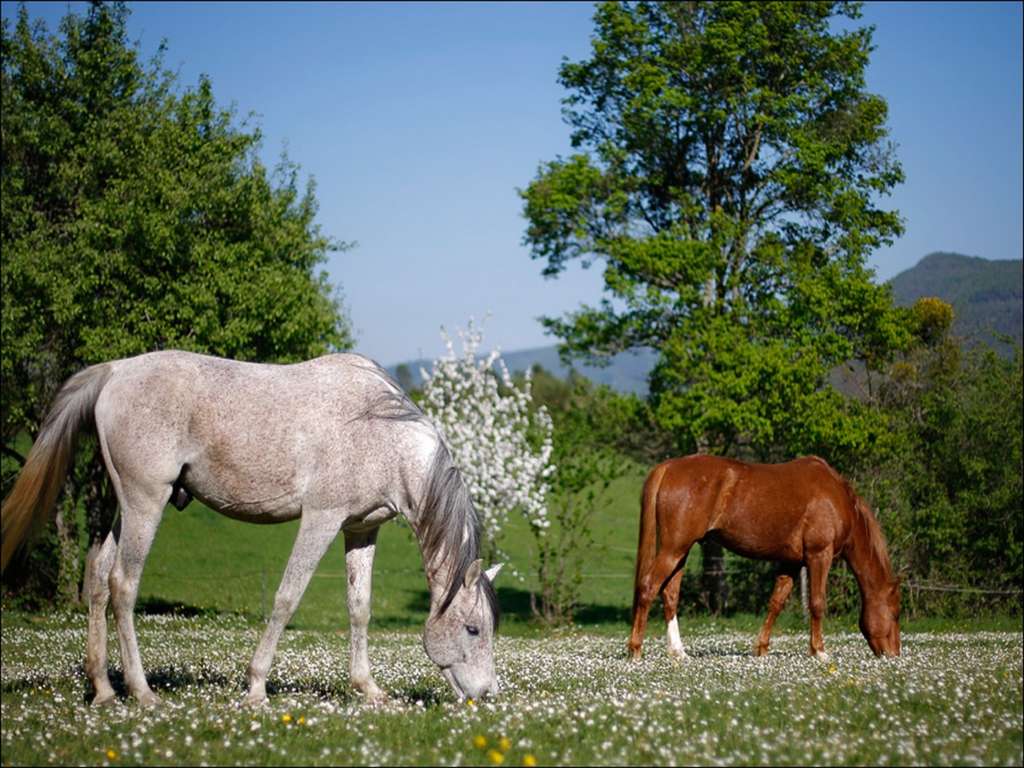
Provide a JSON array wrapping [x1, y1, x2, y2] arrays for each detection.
[[345, 528, 387, 701]]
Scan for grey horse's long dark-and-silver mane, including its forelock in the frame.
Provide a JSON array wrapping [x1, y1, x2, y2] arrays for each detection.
[[356, 361, 501, 631]]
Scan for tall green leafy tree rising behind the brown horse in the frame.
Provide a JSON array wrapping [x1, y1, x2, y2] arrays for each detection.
[[520, 2, 907, 614]]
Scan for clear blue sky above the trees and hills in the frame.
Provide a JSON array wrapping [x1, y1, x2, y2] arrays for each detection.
[[3, 2, 1024, 364]]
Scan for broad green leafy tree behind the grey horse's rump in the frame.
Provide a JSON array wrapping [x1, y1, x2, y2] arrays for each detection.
[[0, 2, 351, 606]]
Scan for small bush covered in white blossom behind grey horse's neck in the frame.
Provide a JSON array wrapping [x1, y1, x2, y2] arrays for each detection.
[[421, 319, 555, 546]]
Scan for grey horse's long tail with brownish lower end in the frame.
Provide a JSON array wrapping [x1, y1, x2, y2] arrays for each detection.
[[0, 364, 111, 570]]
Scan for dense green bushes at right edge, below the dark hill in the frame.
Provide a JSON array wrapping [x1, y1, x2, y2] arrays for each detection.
[[858, 298, 1024, 613]]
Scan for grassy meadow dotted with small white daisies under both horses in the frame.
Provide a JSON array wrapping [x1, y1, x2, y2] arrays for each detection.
[[0, 612, 1024, 766]]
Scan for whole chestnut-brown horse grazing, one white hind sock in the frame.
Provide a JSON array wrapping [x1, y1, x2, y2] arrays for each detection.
[[629, 456, 900, 658]]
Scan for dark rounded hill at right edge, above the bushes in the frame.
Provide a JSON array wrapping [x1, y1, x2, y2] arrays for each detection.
[[890, 253, 1024, 347]]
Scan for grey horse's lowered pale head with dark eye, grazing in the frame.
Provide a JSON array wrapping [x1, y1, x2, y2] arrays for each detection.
[[423, 560, 502, 699]]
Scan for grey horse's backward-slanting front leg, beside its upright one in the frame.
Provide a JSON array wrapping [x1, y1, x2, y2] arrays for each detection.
[[246, 512, 342, 706]]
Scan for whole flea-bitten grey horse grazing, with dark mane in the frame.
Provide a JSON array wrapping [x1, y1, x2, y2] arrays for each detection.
[[0, 351, 500, 705]]
